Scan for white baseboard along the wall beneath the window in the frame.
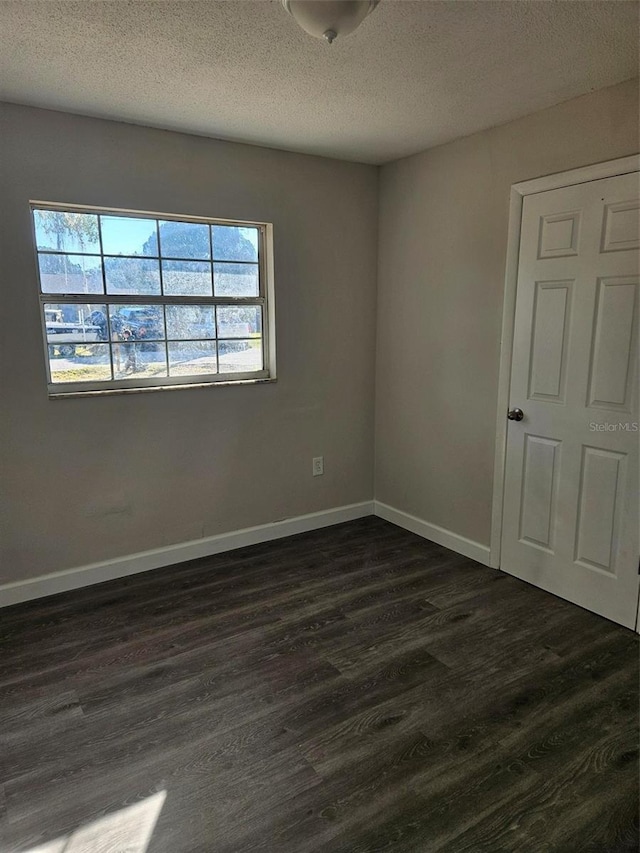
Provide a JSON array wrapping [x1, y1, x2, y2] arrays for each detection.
[[0, 501, 374, 607]]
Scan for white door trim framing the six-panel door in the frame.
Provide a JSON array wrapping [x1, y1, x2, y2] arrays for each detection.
[[489, 154, 640, 576]]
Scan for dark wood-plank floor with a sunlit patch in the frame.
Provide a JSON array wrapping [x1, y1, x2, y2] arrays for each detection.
[[0, 518, 638, 853]]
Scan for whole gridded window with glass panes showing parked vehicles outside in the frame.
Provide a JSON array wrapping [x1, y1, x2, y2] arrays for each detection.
[[32, 203, 275, 396]]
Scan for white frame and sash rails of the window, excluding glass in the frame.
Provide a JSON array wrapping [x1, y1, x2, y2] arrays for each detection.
[[29, 200, 276, 398]]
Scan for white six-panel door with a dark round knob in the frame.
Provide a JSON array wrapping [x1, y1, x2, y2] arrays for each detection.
[[501, 172, 640, 628]]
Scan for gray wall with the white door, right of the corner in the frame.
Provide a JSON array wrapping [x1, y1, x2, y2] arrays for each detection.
[[375, 80, 640, 545]]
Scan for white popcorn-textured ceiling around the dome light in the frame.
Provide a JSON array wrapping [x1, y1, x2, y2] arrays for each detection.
[[0, 0, 639, 163]]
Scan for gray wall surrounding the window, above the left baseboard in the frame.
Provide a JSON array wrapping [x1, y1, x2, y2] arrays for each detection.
[[0, 105, 377, 583]]
